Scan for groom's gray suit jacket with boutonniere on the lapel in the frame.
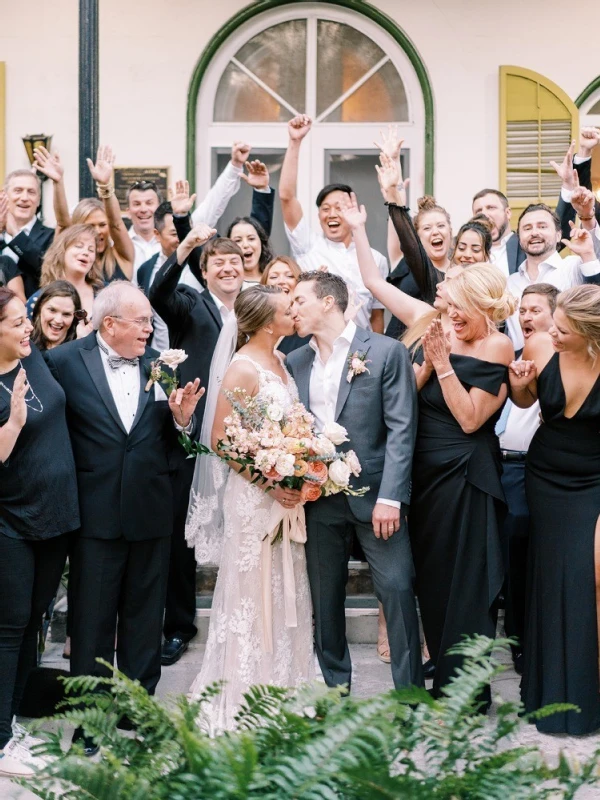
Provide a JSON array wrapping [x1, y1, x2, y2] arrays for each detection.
[[287, 328, 417, 522]]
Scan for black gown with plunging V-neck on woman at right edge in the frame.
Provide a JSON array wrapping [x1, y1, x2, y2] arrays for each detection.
[[522, 353, 600, 735]]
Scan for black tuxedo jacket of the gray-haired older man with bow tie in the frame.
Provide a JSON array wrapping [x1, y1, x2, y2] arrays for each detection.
[[45, 333, 197, 541]]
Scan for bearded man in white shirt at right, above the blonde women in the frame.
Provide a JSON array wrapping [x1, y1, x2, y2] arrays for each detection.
[[506, 203, 600, 350]]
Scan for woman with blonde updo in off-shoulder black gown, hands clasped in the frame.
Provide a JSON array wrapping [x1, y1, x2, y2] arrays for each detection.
[[409, 264, 516, 704]]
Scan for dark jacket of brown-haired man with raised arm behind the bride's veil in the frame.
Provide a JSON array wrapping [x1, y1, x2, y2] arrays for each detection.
[[149, 252, 222, 421]]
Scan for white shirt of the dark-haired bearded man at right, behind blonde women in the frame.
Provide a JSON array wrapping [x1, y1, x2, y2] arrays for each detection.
[[506, 250, 600, 350]]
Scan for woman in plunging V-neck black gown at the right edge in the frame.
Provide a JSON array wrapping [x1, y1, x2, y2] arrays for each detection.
[[510, 286, 600, 735]]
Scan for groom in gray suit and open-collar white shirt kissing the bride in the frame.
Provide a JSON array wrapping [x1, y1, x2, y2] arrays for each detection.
[[287, 272, 423, 688]]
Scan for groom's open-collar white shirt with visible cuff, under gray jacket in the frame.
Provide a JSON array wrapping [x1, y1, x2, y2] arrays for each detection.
[[308, 320, 400, 508]]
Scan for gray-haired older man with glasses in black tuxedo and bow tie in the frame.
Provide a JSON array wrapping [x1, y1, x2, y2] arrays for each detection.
[[47, 281, 204, 708]]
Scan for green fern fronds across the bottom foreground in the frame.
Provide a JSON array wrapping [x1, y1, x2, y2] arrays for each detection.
[[23, 637, 600, 800]]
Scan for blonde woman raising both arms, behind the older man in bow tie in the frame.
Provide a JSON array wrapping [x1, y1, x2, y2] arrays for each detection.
[[35, 147, 135, 283]]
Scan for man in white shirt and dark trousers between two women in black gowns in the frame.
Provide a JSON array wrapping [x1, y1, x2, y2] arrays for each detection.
[[496, 283, 559, 674]]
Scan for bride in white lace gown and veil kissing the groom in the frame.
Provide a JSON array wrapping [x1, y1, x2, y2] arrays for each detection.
[[186, 286, 314, 732]]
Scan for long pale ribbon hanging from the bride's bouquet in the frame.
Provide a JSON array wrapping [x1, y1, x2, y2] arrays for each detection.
[[261, 500, 306, 653]]
